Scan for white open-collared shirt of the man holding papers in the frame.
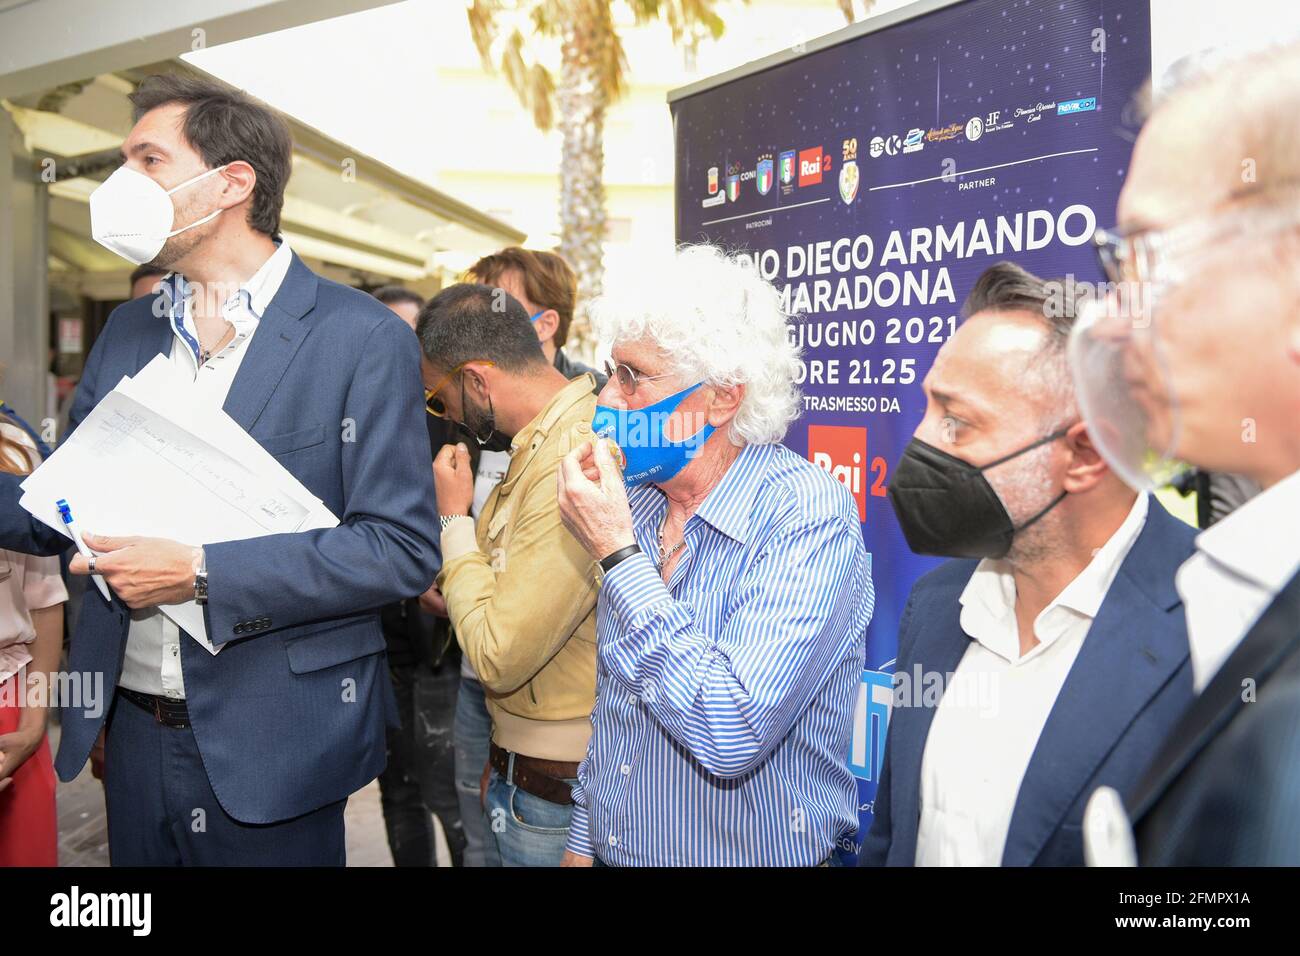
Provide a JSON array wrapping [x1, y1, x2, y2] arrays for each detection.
[[117, 242, 293, 700]]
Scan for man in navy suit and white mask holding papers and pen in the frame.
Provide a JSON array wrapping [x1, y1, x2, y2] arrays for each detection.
[[0, 77, 437, 865]]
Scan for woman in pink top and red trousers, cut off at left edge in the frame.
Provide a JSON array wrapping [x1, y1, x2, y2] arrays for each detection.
[[0, 416, 68, 866]]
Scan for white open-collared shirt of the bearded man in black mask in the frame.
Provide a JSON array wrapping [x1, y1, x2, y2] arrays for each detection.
[[915, 494, 1148, 866]]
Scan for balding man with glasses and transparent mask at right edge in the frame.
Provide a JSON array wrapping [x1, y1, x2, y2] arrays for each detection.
[[1074, 42, 1300, 866]]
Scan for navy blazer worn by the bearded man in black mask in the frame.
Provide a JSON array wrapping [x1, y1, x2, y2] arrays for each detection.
[[858, 497, 1196, 866]]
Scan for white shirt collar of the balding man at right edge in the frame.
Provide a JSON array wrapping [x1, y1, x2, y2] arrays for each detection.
[[1175, 471, 1300, 693]]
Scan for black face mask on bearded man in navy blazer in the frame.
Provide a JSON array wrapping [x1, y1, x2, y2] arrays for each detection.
[[889, 428, 1069, 558]]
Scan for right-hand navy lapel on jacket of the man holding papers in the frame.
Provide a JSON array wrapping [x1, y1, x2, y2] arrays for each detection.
[[222, 254, 317, 432]]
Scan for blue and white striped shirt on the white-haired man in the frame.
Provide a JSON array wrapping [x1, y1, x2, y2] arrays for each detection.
[[568, 445, 875, 866]]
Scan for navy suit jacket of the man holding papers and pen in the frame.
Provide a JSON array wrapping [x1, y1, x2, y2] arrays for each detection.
[[0, 255, 437, 823]]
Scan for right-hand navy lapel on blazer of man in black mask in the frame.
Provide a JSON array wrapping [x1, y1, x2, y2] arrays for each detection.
[[1002, 498, 1188, 866]]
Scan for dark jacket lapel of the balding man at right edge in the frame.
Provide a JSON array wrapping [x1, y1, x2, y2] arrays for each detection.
[[1125, 574, 1300, 823]]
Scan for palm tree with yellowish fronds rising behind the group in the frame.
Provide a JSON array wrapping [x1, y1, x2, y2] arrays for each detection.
[[468, 0, 748, 350]]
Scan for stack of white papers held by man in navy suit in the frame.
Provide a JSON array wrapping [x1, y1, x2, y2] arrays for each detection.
[[20, 355, 338, 654]]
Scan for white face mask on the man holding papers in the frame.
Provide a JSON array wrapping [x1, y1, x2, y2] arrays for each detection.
[[90, 166, 225, 265]]
